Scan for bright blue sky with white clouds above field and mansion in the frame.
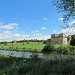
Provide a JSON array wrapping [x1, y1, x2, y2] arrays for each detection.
[[0, 0, 75, 41]]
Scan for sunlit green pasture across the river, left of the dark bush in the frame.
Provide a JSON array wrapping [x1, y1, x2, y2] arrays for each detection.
[[0, 42, 44, 52]]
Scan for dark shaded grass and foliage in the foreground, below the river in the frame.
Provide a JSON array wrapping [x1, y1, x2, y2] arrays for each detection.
[[0, 57, 75, 75]]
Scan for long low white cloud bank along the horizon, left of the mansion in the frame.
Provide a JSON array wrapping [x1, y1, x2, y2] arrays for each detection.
[[0, 31, 51, 41]]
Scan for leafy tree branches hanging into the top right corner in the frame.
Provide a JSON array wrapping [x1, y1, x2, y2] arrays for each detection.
[[53, 0, 75, 22]]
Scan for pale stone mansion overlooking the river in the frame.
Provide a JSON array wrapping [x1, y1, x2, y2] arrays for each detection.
[[51, 33, 71, 44]]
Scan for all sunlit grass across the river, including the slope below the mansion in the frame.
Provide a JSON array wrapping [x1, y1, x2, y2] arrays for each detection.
[[0, 42, 75, 53]]
